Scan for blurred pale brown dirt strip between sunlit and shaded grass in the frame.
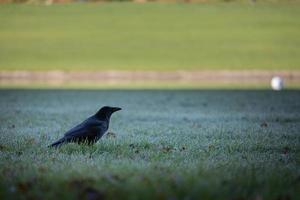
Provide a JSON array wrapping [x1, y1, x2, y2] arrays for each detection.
[[0, 70, 300, 85]]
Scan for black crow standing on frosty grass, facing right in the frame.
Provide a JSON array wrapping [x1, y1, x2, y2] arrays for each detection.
[[49, 106, 122, 147]]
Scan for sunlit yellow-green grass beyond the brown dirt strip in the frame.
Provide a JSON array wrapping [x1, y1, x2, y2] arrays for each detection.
[[0, 3, 300, 70]]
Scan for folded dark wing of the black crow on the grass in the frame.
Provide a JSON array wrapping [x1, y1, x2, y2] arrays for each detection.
[[64, 118, 105, 138]]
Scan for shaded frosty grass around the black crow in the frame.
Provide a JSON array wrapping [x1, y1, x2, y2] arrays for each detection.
[[0, 90, 300, 199]]
